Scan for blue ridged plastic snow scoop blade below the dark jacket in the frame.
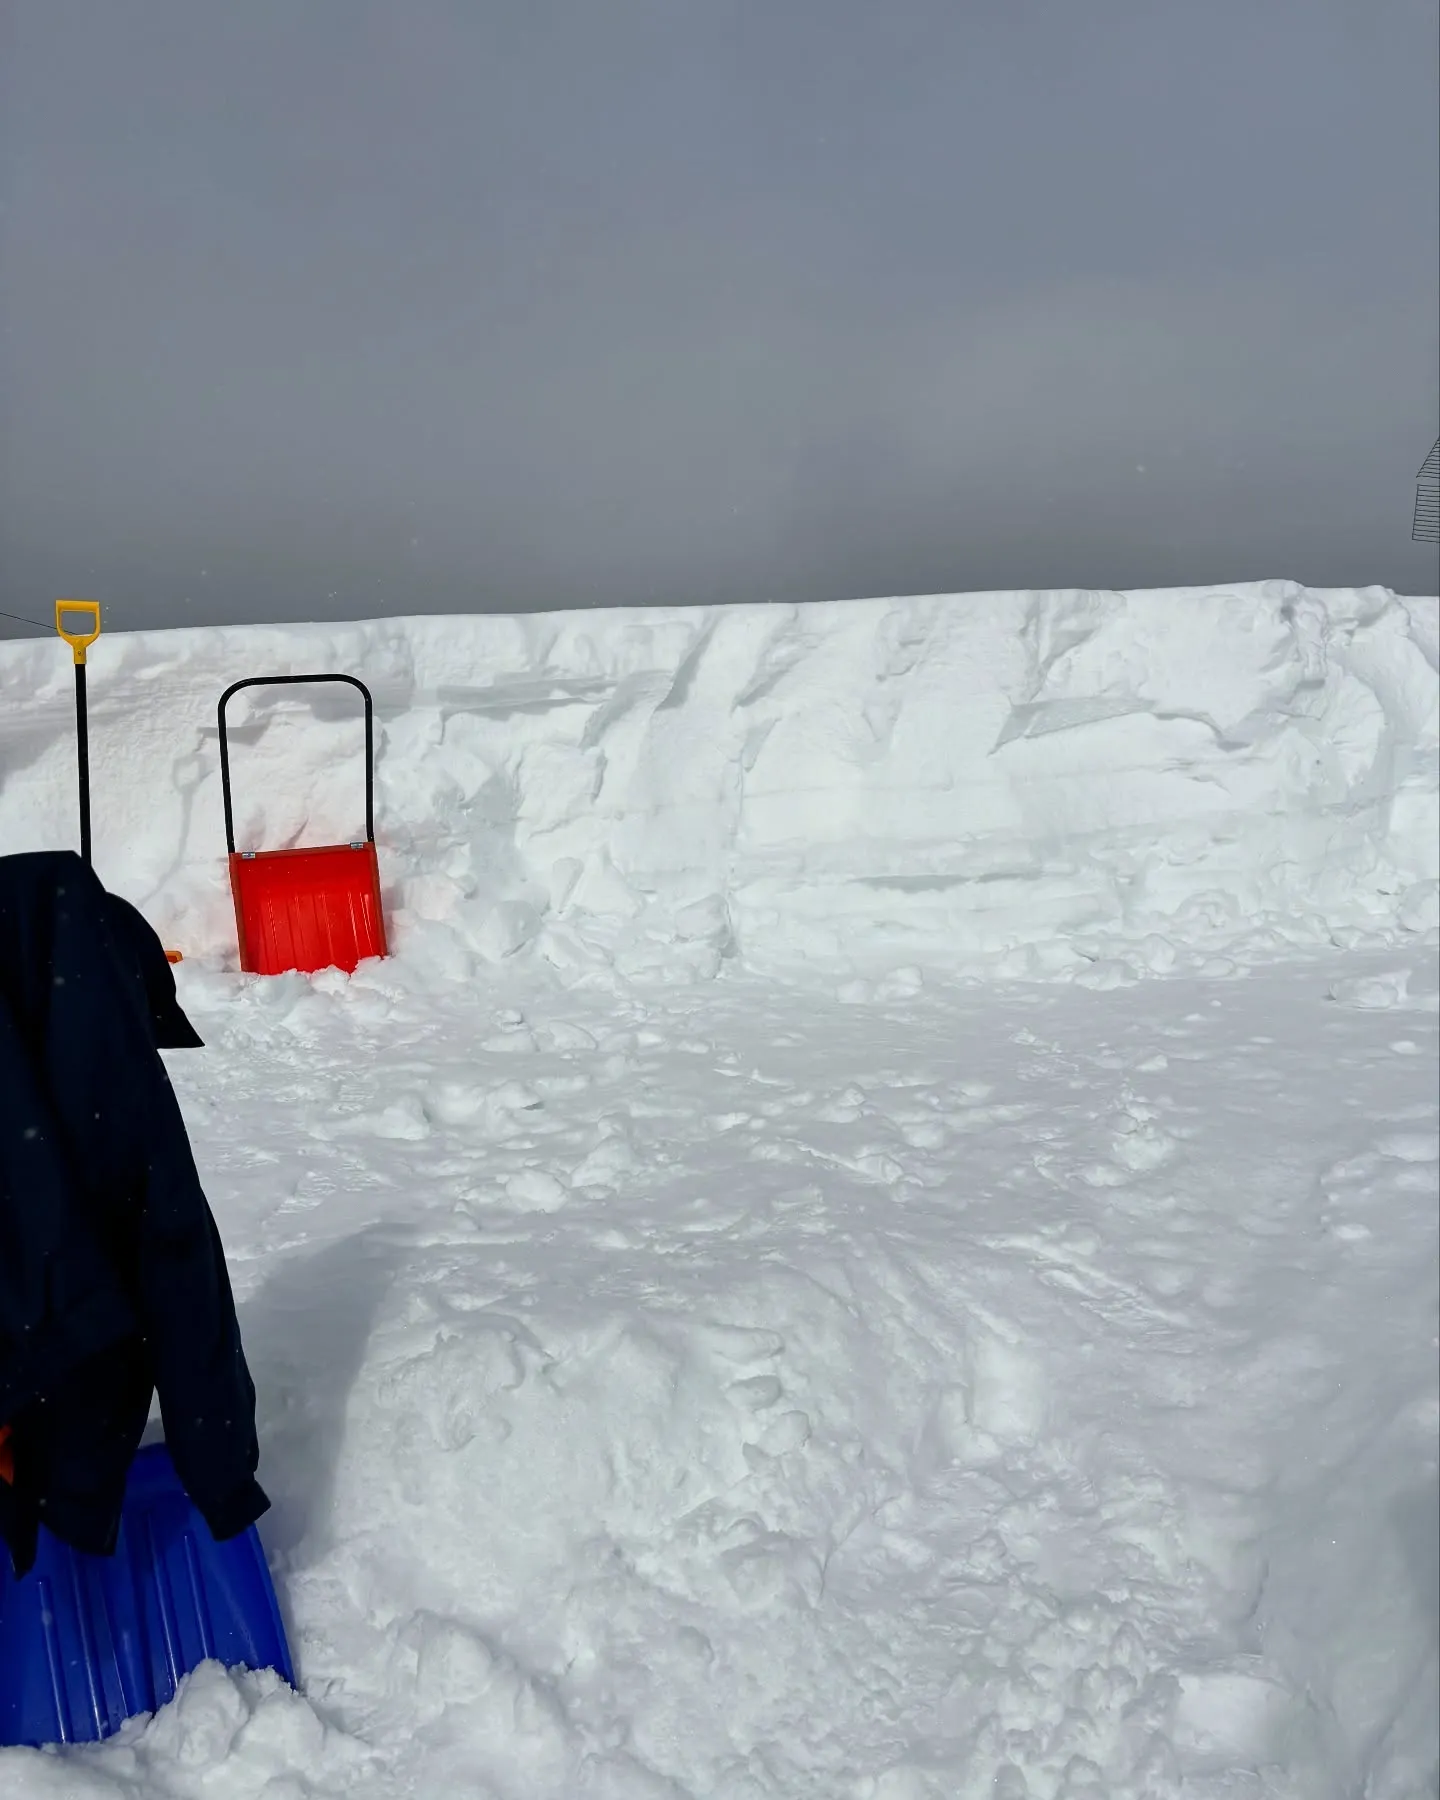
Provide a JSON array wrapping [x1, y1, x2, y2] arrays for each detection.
[[0, 1444, 295, 1746]]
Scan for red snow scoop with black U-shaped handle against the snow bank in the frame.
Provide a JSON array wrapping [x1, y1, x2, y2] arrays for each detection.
[[220, 675, 389, 976]]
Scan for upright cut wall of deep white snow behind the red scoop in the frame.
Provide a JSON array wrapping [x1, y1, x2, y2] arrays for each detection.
[[0, 581, 1440, 983]]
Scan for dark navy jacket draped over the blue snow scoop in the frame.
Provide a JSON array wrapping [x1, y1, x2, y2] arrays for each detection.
[[0, 851, 268, 1573]]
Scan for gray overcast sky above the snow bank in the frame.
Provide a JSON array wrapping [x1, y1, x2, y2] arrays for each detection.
[[0, 0, 1440, 634]]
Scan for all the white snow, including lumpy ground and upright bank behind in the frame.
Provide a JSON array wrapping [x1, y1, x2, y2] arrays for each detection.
[[0, 583, 1440, 1800]]
